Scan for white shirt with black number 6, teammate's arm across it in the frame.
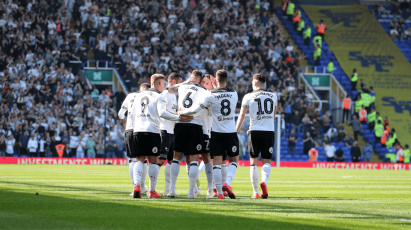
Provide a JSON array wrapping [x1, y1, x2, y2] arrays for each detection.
[[177, 83, 209, 125]]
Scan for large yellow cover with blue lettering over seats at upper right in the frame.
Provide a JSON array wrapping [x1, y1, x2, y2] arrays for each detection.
[[302, 5, 411, 144]]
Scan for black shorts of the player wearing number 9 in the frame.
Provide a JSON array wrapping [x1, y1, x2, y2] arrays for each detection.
[[133, 132, 161, 157]]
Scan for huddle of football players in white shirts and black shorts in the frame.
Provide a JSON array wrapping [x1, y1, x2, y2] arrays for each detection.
[[118, 70, 277, 199]]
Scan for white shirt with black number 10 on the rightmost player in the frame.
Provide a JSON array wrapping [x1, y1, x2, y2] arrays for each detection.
[[242, 89, 277, 131]]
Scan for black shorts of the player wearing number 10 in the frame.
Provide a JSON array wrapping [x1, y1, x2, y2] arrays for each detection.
[[247, 131, 275, 159]]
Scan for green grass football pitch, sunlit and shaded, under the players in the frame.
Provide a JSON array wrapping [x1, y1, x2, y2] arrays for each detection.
[[0, 165, 411, 230]]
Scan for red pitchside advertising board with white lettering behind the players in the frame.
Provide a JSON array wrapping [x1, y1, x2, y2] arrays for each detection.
[[0, 157, 411, 170]]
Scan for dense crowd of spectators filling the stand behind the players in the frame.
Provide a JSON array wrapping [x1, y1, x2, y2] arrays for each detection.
[[0, 0, 308, 157]]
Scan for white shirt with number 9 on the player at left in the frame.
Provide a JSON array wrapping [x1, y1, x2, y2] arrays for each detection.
[[133, 88, 161, 133]]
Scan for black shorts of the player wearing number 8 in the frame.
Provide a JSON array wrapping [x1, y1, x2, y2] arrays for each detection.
[[210, 132, 240, 157]]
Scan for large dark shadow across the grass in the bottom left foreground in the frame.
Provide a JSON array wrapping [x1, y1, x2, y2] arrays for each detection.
[[0, 190, 348, 230]]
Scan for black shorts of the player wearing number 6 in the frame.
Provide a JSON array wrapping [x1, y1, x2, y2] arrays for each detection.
[[174, 123, 204, 155]]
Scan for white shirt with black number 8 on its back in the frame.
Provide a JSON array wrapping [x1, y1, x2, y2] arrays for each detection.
[[207, 88, 238, 133]]
